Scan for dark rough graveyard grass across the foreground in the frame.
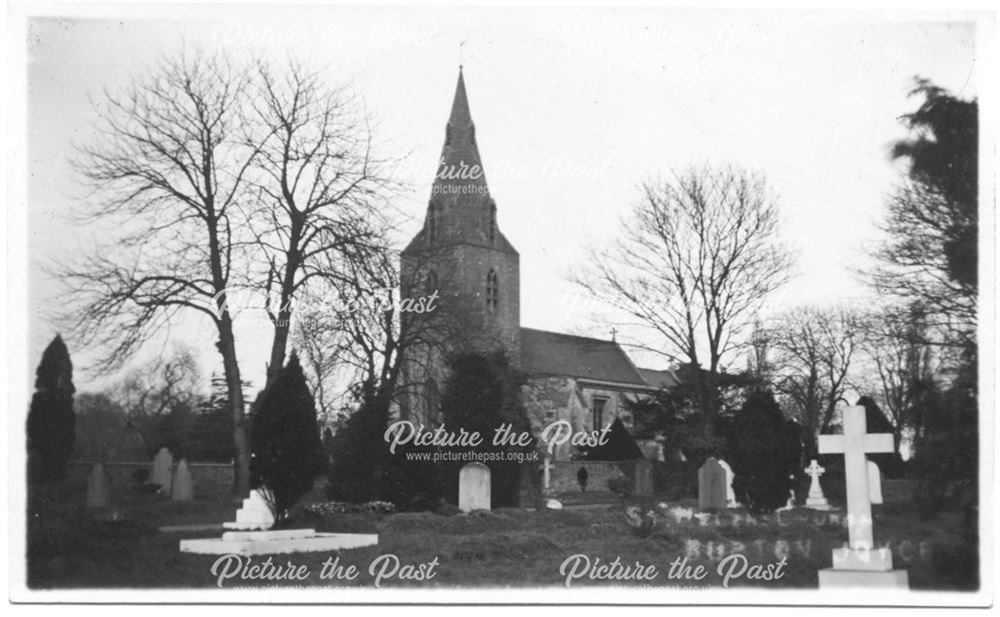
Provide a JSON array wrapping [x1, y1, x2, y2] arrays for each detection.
[[27, 484, 974, 592]]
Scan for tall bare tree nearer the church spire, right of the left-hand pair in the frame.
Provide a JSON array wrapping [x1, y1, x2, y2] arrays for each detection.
[[244, 61, 391, 392]]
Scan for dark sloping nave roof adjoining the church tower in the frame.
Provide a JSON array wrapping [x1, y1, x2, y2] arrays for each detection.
[[521, 328, 650, 386]]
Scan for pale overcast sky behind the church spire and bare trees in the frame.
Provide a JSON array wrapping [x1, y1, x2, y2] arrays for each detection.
[[21, 6, 978, 390]]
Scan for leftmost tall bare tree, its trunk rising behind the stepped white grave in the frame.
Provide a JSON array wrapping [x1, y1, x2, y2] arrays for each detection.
[[59, 53, 257, 493]]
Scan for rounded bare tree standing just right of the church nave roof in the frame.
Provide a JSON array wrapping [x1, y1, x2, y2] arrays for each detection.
[[576, 162, 790, 437]]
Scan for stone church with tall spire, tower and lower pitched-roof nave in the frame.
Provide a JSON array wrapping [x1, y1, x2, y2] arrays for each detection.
[[399, 68, 677, 460]]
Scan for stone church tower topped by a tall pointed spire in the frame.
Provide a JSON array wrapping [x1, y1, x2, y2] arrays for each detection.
[[400, 67, 521, 424]]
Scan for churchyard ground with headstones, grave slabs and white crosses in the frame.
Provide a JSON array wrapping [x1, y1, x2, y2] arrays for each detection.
[[28, 408, 975, 591]]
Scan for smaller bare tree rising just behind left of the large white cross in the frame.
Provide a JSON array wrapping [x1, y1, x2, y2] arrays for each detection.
[[767, 307, 865, 459]]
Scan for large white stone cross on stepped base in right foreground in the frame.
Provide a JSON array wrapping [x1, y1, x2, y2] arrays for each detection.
[[819, 405, 909, 589]]
